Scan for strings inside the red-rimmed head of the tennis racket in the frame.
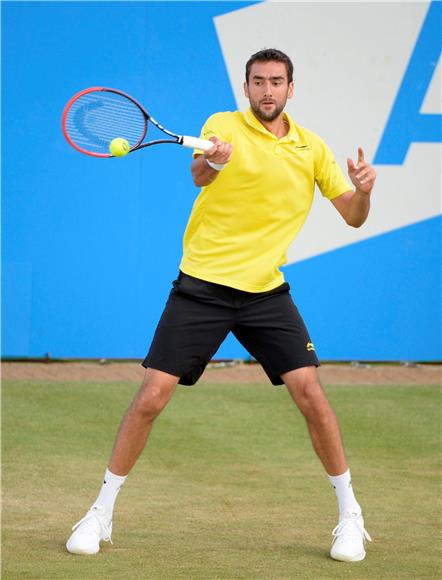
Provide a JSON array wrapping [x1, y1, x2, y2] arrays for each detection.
[[66, 91, 147, 154]]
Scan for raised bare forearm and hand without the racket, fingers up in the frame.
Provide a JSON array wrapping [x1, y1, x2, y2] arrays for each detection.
[[332, 147, 376, 228]]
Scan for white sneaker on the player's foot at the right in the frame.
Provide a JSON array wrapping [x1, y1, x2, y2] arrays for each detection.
[[330, 510, 371, 562]]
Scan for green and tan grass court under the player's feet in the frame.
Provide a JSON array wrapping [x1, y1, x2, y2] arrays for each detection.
[[2, 381, 441, 580]]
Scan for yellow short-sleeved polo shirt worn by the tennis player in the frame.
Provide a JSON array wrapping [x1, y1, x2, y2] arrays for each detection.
[[180, 109, 352, 292]]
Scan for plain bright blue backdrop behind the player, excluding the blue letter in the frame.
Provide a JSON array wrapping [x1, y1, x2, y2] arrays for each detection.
[[2, 2, 441, 360]]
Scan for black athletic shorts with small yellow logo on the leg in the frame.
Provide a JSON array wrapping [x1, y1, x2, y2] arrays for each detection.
[[142, 272, 319, 385]]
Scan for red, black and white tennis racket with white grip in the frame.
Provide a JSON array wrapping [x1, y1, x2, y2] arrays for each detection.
[[62, 87, 213, 157]]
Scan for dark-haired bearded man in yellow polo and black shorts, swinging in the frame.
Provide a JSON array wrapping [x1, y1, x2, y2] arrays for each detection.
[[67, 49, 375, 561]]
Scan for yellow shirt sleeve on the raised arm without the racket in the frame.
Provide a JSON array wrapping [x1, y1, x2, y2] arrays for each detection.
[[314, 135, 353, 200]]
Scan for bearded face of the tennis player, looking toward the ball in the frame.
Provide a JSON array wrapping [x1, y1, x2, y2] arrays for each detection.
[[244, 61, 293, 121]]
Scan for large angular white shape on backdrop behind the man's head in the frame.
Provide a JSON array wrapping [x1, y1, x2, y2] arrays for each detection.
[[215, 2, 441, 263]]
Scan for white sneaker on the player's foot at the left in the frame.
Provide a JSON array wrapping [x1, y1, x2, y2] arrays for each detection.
[[66, 506, 112, 554]]
